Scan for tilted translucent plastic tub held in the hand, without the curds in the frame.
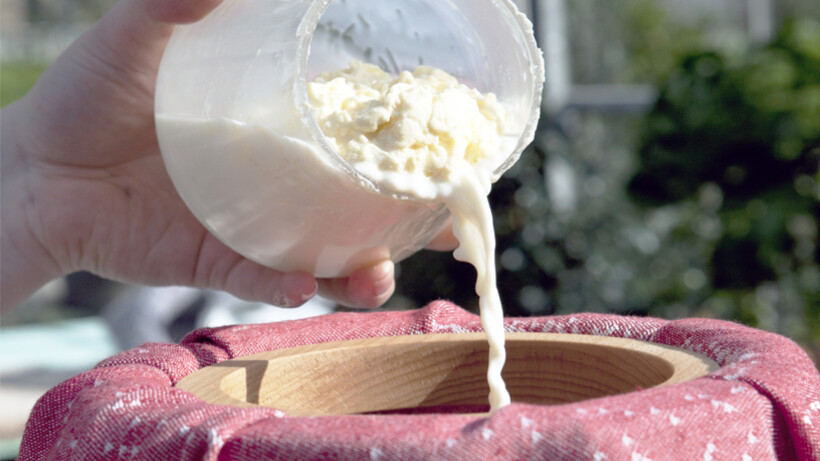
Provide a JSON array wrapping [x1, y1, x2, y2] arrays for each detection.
[[156, 0, 544, 277]]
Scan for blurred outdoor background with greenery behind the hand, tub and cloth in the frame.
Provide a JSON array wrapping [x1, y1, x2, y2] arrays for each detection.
[[0, 0, 820, 459]]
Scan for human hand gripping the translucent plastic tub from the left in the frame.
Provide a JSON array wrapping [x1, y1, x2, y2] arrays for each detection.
[[0, 0, 454, 309]]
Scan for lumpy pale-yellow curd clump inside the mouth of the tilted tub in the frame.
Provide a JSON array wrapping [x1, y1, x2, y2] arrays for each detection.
[[307, 61, 517, 200]]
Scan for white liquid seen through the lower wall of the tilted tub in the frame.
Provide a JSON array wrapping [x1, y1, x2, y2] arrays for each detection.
[[156, 115, 447, 277]]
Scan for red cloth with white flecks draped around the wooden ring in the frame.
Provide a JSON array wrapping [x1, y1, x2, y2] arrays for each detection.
[[19, 302, 820, 461]]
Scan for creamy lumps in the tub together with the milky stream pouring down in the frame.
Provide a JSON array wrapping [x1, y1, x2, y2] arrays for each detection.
[[308, 61, 517, 411]]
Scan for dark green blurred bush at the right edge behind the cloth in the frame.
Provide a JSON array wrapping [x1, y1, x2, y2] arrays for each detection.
[[628, 19, 820, 341]]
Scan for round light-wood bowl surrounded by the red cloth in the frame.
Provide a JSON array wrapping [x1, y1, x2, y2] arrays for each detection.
[[177, 333, 718, 416]]
